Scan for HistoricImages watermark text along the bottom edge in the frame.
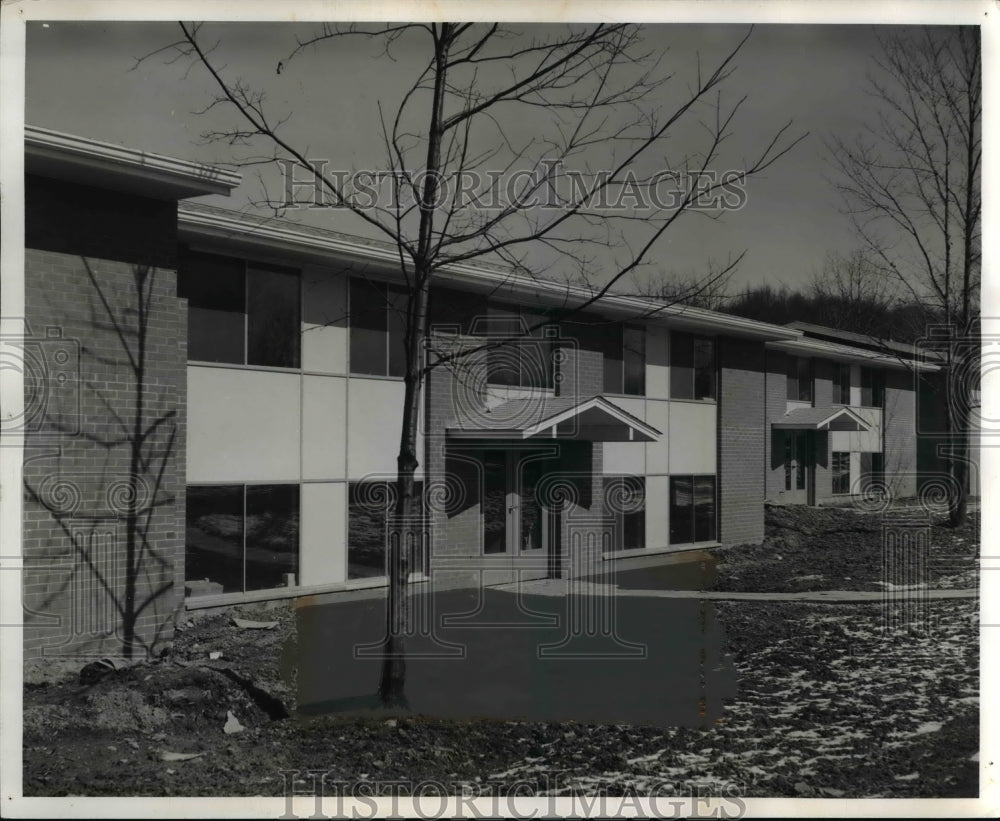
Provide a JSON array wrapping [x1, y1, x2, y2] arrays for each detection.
[[278, 769, 746, 819]]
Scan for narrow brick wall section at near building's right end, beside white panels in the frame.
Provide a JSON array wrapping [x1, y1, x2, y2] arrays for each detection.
[[717, 338, 770, 544]]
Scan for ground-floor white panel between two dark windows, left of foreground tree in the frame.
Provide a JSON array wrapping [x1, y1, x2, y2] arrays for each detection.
[[299, 482, 347, 586]]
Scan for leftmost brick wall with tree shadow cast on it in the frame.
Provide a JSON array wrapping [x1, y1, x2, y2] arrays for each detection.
[[24, 178, 187, 659]]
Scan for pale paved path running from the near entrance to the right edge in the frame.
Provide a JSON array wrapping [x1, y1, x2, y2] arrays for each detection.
[[496, 579, 979, 602]]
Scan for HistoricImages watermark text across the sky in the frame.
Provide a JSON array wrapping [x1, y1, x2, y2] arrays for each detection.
[[278, 159, 747, 213]]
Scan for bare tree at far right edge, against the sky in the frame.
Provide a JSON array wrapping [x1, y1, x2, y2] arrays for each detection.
[[831, 27, 982, 525]]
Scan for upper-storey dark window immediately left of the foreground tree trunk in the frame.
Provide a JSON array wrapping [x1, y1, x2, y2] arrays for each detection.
[[350, 277, 407, 376]]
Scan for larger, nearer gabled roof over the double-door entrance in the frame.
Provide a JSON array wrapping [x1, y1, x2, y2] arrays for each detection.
[[447, 396, 661, 442]]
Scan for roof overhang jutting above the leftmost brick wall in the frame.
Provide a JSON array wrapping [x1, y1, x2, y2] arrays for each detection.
[[24, 126, 242, 200]]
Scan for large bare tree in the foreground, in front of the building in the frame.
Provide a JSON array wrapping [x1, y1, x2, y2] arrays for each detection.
[[150, 23, 803, 705]]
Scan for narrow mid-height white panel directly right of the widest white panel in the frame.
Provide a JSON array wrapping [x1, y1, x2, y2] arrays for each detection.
[[302, 376, 348, 479]]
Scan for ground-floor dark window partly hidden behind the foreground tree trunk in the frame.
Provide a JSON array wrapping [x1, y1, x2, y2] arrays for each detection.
[[347, 481, 428, 579]]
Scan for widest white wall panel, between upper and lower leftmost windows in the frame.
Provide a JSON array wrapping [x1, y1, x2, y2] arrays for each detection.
[[187, 365, 300, 482]]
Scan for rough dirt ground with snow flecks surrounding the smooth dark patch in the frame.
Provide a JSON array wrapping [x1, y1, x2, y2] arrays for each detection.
[[23, 502, 979, 797]]
